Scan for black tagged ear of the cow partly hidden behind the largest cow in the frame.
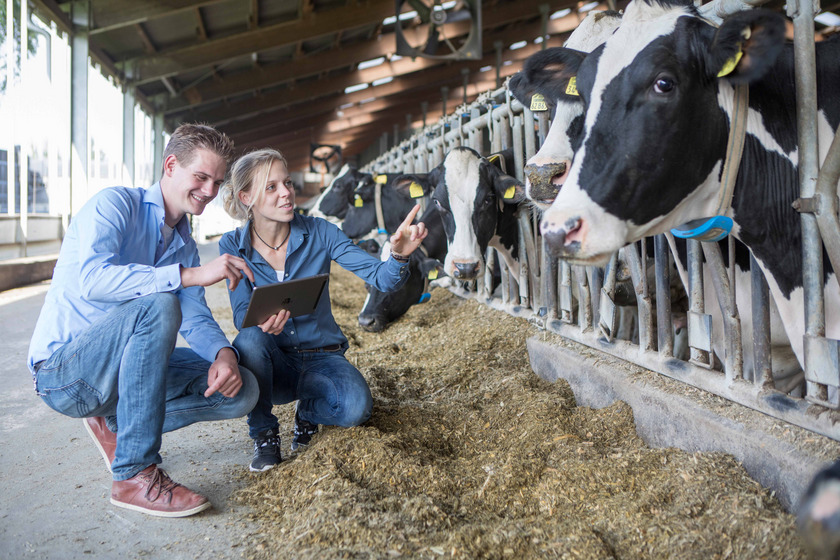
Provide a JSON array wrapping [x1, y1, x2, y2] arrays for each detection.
[[522, 47, 586, 103]]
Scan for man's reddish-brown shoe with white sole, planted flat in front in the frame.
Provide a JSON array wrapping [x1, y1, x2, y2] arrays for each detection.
[[111, 465, 210, 517]]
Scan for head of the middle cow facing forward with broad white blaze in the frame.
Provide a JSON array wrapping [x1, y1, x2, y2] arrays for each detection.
[[432, 147, 525, 280]]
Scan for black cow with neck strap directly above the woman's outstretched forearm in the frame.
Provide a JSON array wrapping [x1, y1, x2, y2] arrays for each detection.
[[341, 173, 419, 239]]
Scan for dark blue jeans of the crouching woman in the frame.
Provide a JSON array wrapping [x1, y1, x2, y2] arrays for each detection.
[[233, 327, 373, 438]]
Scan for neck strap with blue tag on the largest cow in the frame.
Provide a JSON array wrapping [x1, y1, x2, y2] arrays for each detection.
[[671, 84, 750, 241]]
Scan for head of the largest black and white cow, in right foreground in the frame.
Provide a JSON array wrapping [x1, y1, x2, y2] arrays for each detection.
[[540, 0, 784, 264]]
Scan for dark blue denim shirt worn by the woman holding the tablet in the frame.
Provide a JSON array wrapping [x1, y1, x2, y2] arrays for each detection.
[[219, 214, 409, 349]]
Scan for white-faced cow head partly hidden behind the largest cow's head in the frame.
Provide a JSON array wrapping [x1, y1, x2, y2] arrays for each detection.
[[508, 11, 621, 210]]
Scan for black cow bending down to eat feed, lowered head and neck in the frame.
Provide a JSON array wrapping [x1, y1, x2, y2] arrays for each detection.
[[359, 206, 446, 332]]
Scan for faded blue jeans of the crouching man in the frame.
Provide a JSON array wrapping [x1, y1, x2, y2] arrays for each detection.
[[36, 293, 259, 480]]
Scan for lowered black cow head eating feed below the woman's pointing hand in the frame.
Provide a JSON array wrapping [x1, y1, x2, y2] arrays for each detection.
[[359, 243, 443, 332]]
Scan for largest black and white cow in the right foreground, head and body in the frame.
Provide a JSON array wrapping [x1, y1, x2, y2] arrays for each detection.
[[541, 0, 840, 370]]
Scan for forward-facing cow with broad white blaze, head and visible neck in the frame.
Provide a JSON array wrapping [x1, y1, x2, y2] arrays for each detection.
[[418, 147, 525, 280]]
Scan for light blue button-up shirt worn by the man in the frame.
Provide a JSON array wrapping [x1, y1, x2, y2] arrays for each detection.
[[28, 183, 231, 371]]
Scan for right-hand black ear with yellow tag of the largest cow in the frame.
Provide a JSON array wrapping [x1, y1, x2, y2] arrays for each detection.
[[707, 9, 785, 84]]
